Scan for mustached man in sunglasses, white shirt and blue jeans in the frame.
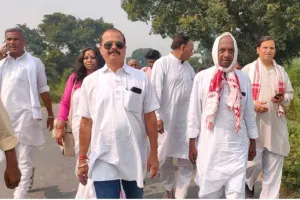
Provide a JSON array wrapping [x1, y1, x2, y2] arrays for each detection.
[[77, 29, 159, 199]]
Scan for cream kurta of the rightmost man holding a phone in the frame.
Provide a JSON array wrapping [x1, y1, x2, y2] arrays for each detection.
[[243, 60, 294, 156]]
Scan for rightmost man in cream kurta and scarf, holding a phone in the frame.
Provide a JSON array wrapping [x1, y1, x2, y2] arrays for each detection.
[[243, 36, 293, 199]]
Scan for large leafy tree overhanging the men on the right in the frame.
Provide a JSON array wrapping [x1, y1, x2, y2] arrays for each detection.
[[121, 0, 300, 65]]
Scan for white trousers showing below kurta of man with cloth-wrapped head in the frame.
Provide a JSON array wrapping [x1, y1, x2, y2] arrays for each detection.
[[199, 186, 245, 199]]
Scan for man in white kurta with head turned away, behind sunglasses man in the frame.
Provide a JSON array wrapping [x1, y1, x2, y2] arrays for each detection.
[[152, 34, 195, 199]]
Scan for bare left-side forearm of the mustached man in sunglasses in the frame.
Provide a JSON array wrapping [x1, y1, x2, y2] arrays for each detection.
[[79, 117, 93, 156]]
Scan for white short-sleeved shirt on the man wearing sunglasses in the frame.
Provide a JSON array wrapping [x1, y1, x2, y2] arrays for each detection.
[[78, 64, 159, 188]]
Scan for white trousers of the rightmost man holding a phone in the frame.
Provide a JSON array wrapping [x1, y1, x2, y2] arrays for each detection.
[[246, 148, 284, 199]]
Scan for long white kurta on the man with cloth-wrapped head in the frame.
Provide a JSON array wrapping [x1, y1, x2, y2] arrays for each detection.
[[188, 67, 258, 196]]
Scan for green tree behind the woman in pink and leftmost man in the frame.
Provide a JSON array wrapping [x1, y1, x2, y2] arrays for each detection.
[[18, 13, 113, 84]]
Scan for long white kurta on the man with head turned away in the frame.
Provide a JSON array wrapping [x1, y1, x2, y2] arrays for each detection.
[[151, 53, 195, 161]]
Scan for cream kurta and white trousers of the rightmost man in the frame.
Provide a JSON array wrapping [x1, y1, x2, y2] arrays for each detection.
[[243, 59, 293, 199]]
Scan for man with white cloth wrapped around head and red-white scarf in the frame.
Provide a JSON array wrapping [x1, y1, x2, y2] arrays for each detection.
[[188, 33, 258, 199]]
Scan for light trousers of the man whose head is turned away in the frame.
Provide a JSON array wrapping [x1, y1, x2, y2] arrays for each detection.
[[160, 157, 193, 199]]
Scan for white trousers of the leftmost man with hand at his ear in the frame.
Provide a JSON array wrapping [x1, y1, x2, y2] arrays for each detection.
[[14, 143, 36, 199]]
